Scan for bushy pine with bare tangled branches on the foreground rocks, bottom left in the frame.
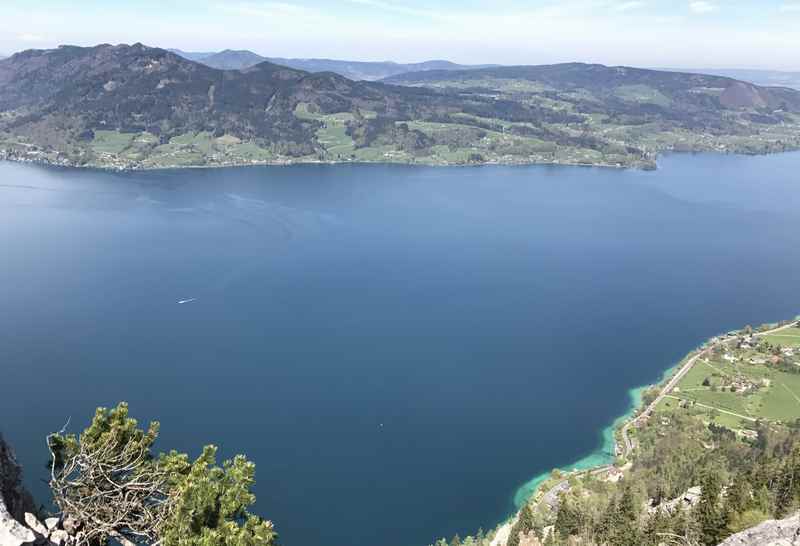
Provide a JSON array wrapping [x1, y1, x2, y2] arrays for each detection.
[[48, 402, 277, 546]]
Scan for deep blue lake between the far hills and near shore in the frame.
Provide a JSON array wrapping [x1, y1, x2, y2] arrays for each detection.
[[0, 154, 800, 546]]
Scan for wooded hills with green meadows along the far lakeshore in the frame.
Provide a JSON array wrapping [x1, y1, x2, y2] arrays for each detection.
[[0, 44, 800, 169]]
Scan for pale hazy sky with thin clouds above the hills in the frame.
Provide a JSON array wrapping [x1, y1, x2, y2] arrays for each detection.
[[0, 0, 800, 70]]
